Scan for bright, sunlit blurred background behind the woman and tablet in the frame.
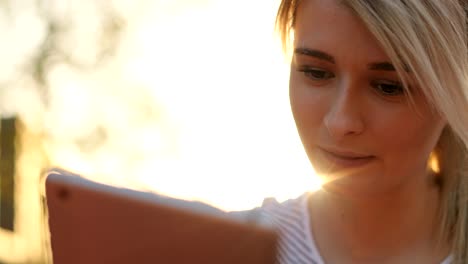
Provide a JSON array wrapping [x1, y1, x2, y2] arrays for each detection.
[[0, 0, 319, 263]]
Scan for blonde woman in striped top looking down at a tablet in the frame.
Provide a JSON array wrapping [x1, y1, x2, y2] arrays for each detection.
[[261, 0, 468, 264]]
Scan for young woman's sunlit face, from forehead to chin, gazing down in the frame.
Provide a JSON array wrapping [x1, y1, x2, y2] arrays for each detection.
[[290, 0, 445, 193]]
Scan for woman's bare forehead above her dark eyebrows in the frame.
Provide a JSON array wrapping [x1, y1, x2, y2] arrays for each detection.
[[294, 0, 388, 61]]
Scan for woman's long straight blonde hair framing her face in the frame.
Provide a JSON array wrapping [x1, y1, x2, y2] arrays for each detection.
[[276, 0, 468, 263]]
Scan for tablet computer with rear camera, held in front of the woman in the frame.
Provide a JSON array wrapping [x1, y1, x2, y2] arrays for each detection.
[[45, 170, 277, 264]]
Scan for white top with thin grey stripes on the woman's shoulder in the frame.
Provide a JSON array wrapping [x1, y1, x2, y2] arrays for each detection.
[[259, 193, 451, 264]]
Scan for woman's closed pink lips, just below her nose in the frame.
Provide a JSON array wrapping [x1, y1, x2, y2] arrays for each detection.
[[319, 147, 375, 167]]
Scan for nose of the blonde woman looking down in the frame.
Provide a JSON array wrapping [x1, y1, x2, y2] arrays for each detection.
[[323, 82, 365, 141]]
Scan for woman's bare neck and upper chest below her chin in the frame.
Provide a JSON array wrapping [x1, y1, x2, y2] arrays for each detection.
[[310, 174, 448, 263]]
